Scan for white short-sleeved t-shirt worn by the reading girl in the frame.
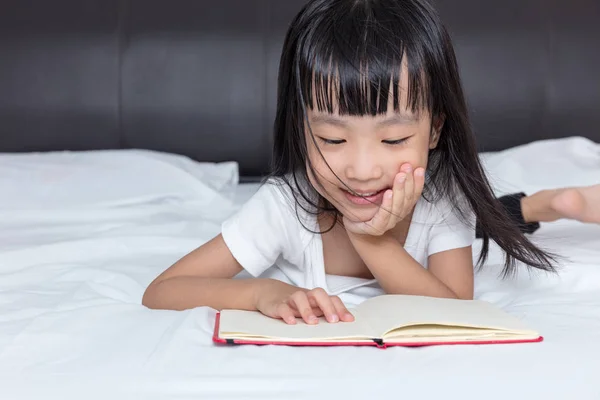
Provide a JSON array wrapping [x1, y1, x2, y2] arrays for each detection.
[[221, 180, 475, 306]]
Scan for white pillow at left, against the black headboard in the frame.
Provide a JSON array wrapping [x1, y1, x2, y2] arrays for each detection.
[[0, 150, 239, 210]]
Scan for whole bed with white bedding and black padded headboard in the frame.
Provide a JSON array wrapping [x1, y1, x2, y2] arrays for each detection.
[[0, 0, 600, 400]]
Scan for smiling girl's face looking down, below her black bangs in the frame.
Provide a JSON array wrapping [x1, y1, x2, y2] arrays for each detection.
[[306, 81, 441, 221]]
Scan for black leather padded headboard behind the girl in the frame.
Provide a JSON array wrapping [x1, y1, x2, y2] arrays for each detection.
[[0, 0, 600, 176]]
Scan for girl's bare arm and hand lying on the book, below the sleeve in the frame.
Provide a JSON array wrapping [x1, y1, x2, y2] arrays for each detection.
[[142, 235, 354, 324]]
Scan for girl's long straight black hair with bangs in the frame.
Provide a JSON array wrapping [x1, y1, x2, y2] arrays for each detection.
[[270, 0, 555, 276]]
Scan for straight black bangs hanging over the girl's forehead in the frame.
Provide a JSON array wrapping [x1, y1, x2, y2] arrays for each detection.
[[295, 2, 434, 116]]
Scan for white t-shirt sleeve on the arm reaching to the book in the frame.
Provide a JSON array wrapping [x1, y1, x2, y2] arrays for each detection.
[[221, 182, 294, 277]]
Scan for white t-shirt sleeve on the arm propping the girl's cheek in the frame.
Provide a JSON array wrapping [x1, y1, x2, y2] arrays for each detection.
[[427, 199, 475, 256]]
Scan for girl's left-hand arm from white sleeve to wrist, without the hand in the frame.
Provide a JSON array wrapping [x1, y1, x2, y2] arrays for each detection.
[[142, 185, 287, 310]]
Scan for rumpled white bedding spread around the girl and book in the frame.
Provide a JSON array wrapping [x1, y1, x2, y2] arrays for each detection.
[[0, 137, 600, 400]]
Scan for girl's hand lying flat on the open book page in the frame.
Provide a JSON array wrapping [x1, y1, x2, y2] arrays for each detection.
[[256, 280, 354, 325]]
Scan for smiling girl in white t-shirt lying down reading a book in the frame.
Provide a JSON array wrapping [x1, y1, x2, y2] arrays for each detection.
[[143, 0, 554, 324]]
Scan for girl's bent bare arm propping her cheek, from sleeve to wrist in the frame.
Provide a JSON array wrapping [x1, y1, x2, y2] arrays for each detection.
[[349, 233, 473, 299]]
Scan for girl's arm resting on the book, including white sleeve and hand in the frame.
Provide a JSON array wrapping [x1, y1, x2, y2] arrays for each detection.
[[142, 181, 353, 324]]
